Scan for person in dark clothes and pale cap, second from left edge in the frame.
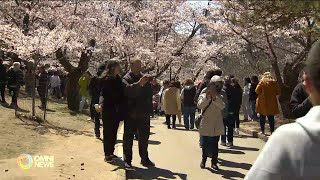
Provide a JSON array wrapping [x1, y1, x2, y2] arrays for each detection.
[[7, 62, 24, 108]]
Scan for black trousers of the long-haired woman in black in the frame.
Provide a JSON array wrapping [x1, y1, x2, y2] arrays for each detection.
[[103, 117, 120, 156]]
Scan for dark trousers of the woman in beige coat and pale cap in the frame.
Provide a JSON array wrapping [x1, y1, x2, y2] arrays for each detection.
[[202, 136, 220, 163]]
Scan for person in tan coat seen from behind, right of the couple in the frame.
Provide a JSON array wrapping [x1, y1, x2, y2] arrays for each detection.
[[163, 82, 181, 129]]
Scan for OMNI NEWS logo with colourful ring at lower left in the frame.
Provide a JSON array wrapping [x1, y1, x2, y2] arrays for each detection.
[[17, 154, 54, 170]]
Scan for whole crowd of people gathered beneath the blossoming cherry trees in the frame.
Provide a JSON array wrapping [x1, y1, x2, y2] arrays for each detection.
[[0, 39, 320, 179]]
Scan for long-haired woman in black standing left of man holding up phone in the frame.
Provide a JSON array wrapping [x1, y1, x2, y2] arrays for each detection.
[[95, 60, 127, 162]]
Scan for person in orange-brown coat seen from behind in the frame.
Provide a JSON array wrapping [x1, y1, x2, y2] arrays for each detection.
[[256, 72, 280, 134]]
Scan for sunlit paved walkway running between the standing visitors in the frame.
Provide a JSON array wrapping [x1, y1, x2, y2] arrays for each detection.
[[118, 118, 264, 180]]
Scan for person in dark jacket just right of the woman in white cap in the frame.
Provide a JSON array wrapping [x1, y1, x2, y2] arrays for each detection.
[[229, 78, 243, 136]]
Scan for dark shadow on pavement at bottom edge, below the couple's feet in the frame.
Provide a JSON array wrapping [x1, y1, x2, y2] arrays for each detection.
[[126, 167, 187, 180]]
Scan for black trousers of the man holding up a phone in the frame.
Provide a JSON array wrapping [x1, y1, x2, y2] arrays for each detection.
[[123, 116, 150, 162]]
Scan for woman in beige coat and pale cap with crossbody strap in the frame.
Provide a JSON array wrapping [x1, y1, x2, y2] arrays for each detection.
[[198, 83, 225, 170]]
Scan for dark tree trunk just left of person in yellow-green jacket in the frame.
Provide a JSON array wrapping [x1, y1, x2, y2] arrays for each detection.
[[66, 68, 82, 111]]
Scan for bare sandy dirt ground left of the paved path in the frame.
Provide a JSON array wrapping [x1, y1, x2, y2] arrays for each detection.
[[0, 103, 124, 180]]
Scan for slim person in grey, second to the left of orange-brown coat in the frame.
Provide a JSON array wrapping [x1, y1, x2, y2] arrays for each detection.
[[242, 77, 252, 121]]
